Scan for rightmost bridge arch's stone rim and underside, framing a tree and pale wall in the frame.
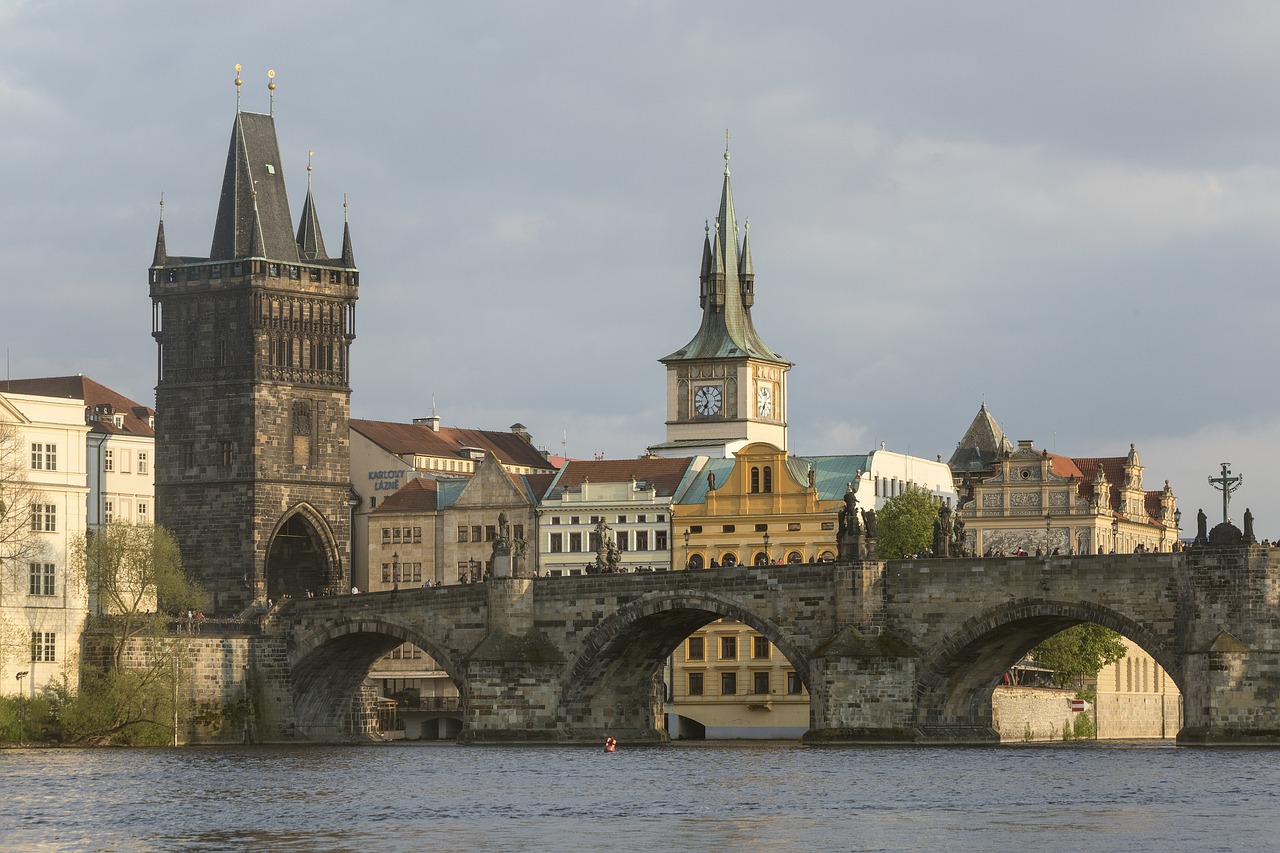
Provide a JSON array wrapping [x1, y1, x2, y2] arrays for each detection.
[[916, 598, 1185, 731]]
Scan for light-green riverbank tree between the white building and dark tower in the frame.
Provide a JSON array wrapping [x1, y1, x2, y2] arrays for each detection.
[[59, 523, 204, 743]]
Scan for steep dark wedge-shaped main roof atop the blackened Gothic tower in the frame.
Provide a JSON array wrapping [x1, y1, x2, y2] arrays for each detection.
[[209, 113, 299, 263]]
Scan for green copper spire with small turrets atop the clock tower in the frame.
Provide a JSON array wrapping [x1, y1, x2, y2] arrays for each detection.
[[659, 151, 791, 365]]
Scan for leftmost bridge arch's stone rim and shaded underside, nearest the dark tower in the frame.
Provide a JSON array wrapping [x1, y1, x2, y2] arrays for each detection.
[[291, 616, 465, 740]]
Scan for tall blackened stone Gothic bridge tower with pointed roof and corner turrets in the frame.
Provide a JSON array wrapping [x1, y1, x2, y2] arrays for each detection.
[[150, 79, 360, 613]]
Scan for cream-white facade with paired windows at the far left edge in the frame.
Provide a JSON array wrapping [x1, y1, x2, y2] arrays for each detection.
[[0, 391, 90, 695]]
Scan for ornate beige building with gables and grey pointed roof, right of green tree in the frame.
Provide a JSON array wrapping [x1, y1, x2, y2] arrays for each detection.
[[951, 403, 1180, 555]]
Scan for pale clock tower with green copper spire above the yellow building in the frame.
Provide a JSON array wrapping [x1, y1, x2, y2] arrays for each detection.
[[649, 147, 791, 457]]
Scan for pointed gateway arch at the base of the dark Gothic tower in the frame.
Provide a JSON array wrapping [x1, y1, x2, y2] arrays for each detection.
[[264, 503, 344, 601]]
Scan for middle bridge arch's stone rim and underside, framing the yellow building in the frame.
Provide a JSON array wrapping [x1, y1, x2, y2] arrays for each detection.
[[561, 589, 809, 739]]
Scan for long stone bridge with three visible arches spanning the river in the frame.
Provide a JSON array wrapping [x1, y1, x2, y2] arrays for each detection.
[[251, 547, 1280, 743]]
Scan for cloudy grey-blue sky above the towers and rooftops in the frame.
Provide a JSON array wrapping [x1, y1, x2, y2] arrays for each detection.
[[0, 0, 1280, 539]]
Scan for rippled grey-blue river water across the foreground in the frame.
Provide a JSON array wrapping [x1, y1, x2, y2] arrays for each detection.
[[0, 742, 1280, 853]]
